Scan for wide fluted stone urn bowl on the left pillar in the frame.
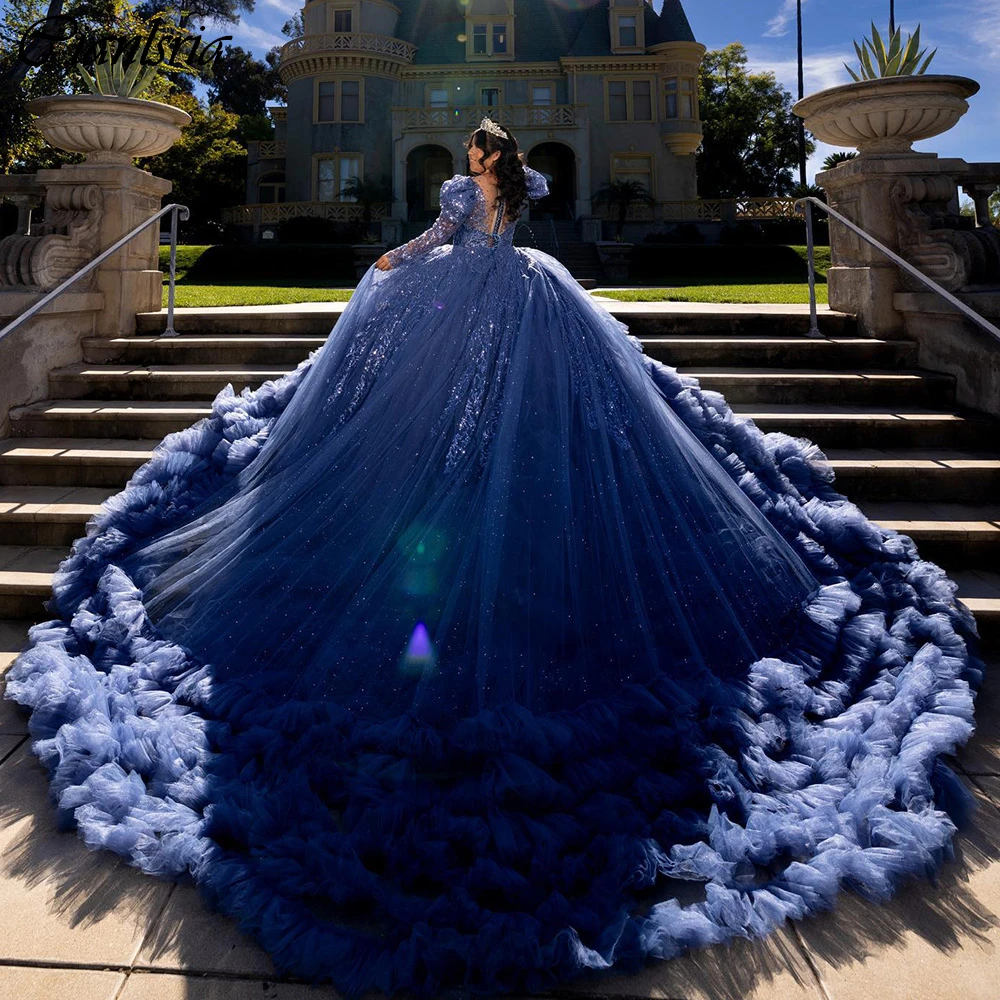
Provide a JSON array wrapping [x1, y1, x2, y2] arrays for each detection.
[[26, 94, 191, 165]]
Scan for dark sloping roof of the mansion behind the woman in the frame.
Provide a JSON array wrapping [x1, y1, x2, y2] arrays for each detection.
[[396, 0, 694, 64]]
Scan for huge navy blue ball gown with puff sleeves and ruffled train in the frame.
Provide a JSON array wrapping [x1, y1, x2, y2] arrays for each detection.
[[1, 171, 980, 994]]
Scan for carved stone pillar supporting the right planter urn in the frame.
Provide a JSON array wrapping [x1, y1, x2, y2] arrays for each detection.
[[816, 152, 968, 338]]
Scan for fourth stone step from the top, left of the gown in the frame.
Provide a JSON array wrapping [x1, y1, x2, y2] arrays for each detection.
[[10, 399, 212, 441]]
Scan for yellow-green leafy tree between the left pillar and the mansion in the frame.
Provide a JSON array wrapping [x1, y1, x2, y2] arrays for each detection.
[[139, 91, 247, 240]]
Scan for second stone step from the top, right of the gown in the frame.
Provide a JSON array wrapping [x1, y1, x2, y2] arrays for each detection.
[[642, 337, 917, 370]]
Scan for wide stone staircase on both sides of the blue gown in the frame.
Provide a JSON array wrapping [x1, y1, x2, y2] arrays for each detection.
[[0, 303, 1000, 644]]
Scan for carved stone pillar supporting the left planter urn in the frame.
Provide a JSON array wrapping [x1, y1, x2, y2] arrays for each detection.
[[36, 163, 173, 337]]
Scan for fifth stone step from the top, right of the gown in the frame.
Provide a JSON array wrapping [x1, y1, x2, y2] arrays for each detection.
[[826, 448, 1000, 504]]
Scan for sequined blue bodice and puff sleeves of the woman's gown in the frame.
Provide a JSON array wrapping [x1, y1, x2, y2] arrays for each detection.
[[388, 167, 549, 267]]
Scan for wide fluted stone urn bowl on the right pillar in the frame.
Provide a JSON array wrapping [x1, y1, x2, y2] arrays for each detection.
[[792, 74, 979, 156]]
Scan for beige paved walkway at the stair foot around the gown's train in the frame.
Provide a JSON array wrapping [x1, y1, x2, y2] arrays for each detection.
[[0, 623, 1000, 1000]]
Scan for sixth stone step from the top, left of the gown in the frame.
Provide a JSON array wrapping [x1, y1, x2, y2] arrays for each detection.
[[0, 486, 112, 546]]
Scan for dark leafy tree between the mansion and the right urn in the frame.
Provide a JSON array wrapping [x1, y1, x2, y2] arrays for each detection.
[[698, 42, 816, 198]]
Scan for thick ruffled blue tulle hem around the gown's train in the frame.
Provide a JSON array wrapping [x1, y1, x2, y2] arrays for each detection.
[[1, 326, 980, 994]]
